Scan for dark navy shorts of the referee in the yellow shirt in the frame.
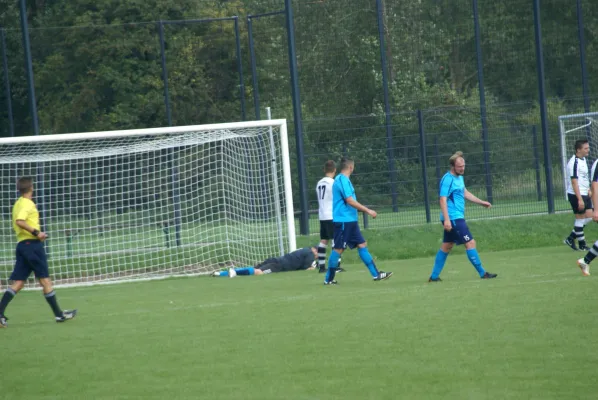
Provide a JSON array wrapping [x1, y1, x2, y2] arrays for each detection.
[[10, 240, 50, 281]]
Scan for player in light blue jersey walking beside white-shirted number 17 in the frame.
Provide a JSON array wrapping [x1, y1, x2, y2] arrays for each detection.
[[324, 158, 392, 285]]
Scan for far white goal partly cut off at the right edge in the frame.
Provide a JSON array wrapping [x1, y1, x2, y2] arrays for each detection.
[[559, 112, 598, 195]]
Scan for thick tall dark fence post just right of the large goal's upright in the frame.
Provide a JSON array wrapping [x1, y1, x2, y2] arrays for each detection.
[[284, 0, 309, 235]]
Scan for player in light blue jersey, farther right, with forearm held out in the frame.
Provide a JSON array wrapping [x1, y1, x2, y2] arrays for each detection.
[[428, 151, 497, 282]]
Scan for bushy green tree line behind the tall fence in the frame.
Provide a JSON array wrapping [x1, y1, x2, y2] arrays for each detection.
[[0, 0, 598, 212]]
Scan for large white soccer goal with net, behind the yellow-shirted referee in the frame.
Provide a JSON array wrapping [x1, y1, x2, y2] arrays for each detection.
[[0, 120, 296, 287]]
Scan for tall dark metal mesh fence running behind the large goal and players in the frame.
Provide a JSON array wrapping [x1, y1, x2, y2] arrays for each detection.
[[0, 0, 598, 233]]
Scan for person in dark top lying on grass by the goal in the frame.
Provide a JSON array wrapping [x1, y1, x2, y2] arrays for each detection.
[[212, 247, 318, 278]]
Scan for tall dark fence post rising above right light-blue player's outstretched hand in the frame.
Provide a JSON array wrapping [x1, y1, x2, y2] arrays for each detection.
[[473, 0, 493, 203]]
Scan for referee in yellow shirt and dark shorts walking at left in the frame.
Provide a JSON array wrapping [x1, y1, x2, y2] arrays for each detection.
[[0, 177, 77, 328]]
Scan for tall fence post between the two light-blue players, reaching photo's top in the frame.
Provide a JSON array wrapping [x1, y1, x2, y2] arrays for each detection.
[[376, 0, 399, 212]]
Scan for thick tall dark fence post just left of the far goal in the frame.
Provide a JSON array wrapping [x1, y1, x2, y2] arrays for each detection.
[[534, 0, 554, 214]]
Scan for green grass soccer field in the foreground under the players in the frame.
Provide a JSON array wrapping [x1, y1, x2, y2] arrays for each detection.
[[0, 246, 598, 400]]
